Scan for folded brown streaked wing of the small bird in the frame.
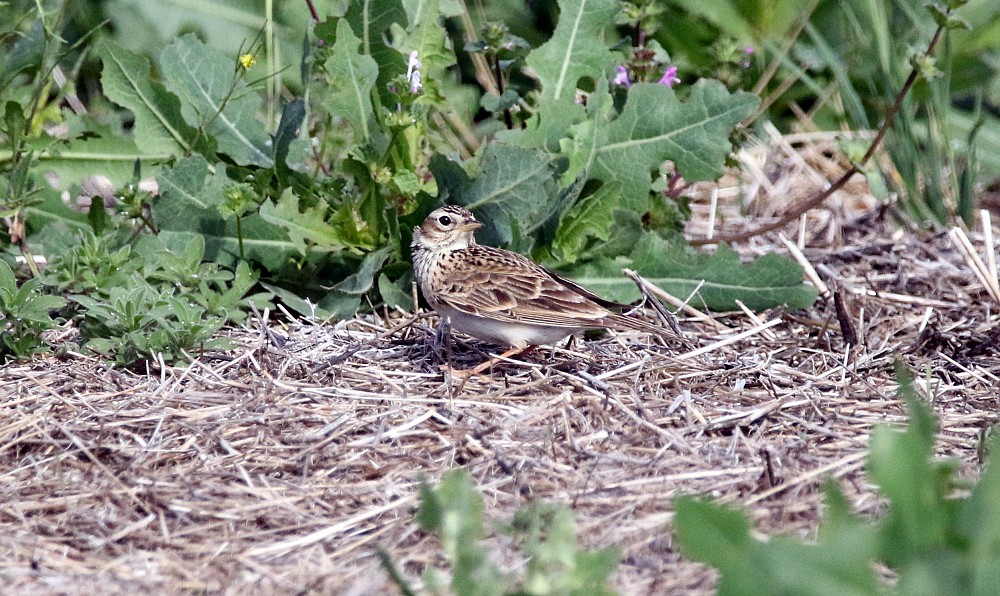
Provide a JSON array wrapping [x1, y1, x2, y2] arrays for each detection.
[[436, 245, 613, 328]]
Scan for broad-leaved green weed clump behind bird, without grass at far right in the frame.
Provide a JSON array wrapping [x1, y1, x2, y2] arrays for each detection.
[[0, 0, 836, 365]]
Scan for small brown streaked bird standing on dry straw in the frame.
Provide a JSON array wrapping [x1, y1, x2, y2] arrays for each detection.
[[410, 205, 666, 373]]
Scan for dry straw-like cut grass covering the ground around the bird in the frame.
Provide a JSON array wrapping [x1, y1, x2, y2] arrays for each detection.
[[0, 133, 1000, 594]]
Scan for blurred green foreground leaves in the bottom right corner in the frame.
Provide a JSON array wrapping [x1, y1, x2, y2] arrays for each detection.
[[675, 365, 1000, 594]]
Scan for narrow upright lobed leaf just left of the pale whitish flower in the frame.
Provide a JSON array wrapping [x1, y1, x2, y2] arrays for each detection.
[[325, 19, 380, 143]]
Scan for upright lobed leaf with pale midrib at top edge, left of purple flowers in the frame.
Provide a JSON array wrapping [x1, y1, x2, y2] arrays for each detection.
[[527, 0, 620, 103]]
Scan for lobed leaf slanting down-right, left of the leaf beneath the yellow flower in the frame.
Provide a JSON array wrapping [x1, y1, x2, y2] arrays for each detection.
[[97, 38, 195, 155]]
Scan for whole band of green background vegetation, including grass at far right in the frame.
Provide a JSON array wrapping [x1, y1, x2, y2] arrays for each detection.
[[0, 0, 1000, 364]]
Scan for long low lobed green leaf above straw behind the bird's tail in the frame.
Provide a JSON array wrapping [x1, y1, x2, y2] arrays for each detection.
[[566, 234, 816, 311]]
